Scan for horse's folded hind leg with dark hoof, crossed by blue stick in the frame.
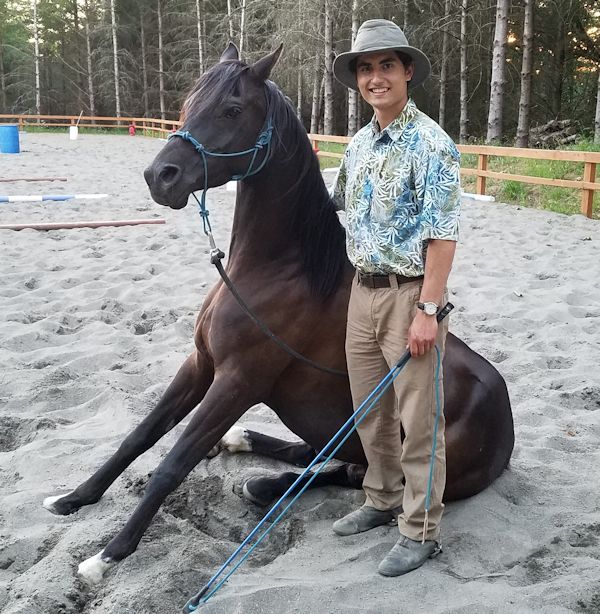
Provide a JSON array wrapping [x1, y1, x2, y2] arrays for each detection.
[[243, 463, 366, 506]]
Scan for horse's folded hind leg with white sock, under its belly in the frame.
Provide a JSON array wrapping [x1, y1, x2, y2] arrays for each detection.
[[209, 425, 317, 467]]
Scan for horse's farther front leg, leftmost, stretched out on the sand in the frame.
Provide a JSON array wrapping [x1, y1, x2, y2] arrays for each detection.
[[43, 353, 212, 515]]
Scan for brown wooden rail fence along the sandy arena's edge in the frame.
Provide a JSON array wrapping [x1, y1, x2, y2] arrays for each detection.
[[0, 115, 600, 217]]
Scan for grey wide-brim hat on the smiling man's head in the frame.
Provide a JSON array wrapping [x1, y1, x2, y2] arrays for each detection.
[[333, 19, 431, 91]]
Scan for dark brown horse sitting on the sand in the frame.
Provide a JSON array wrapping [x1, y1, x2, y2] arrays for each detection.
[[44, 45, 514, 582]]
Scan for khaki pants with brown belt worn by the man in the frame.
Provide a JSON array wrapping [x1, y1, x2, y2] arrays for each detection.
[[346, 276, 448, 540]]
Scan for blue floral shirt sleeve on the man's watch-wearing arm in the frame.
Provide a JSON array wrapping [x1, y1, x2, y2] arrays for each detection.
[[415, 139, 461, 241]]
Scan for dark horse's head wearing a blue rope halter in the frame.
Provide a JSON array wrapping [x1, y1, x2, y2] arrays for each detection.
[[144, 43, 282, 209]]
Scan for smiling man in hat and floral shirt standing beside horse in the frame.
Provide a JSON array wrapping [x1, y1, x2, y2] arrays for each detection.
[[332, 19, 460, 576]]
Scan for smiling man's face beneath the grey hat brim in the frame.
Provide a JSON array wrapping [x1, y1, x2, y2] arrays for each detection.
[[356, 51, 413, 118]]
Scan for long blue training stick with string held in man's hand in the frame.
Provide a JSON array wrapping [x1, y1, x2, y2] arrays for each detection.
[[183, 303, 454, 613]]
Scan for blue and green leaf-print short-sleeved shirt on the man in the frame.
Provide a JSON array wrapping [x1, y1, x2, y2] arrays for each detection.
[[331, 100, 461, 277]]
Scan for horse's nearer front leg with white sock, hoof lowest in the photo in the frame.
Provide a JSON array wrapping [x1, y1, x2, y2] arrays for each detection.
[[79, 375, 256, 584]]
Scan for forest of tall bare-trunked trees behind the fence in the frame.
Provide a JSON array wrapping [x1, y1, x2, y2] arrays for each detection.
[[0, 0, 600, 146]]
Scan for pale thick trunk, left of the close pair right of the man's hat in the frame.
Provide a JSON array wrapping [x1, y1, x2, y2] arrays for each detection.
[[486, 0, 509, 143]]
